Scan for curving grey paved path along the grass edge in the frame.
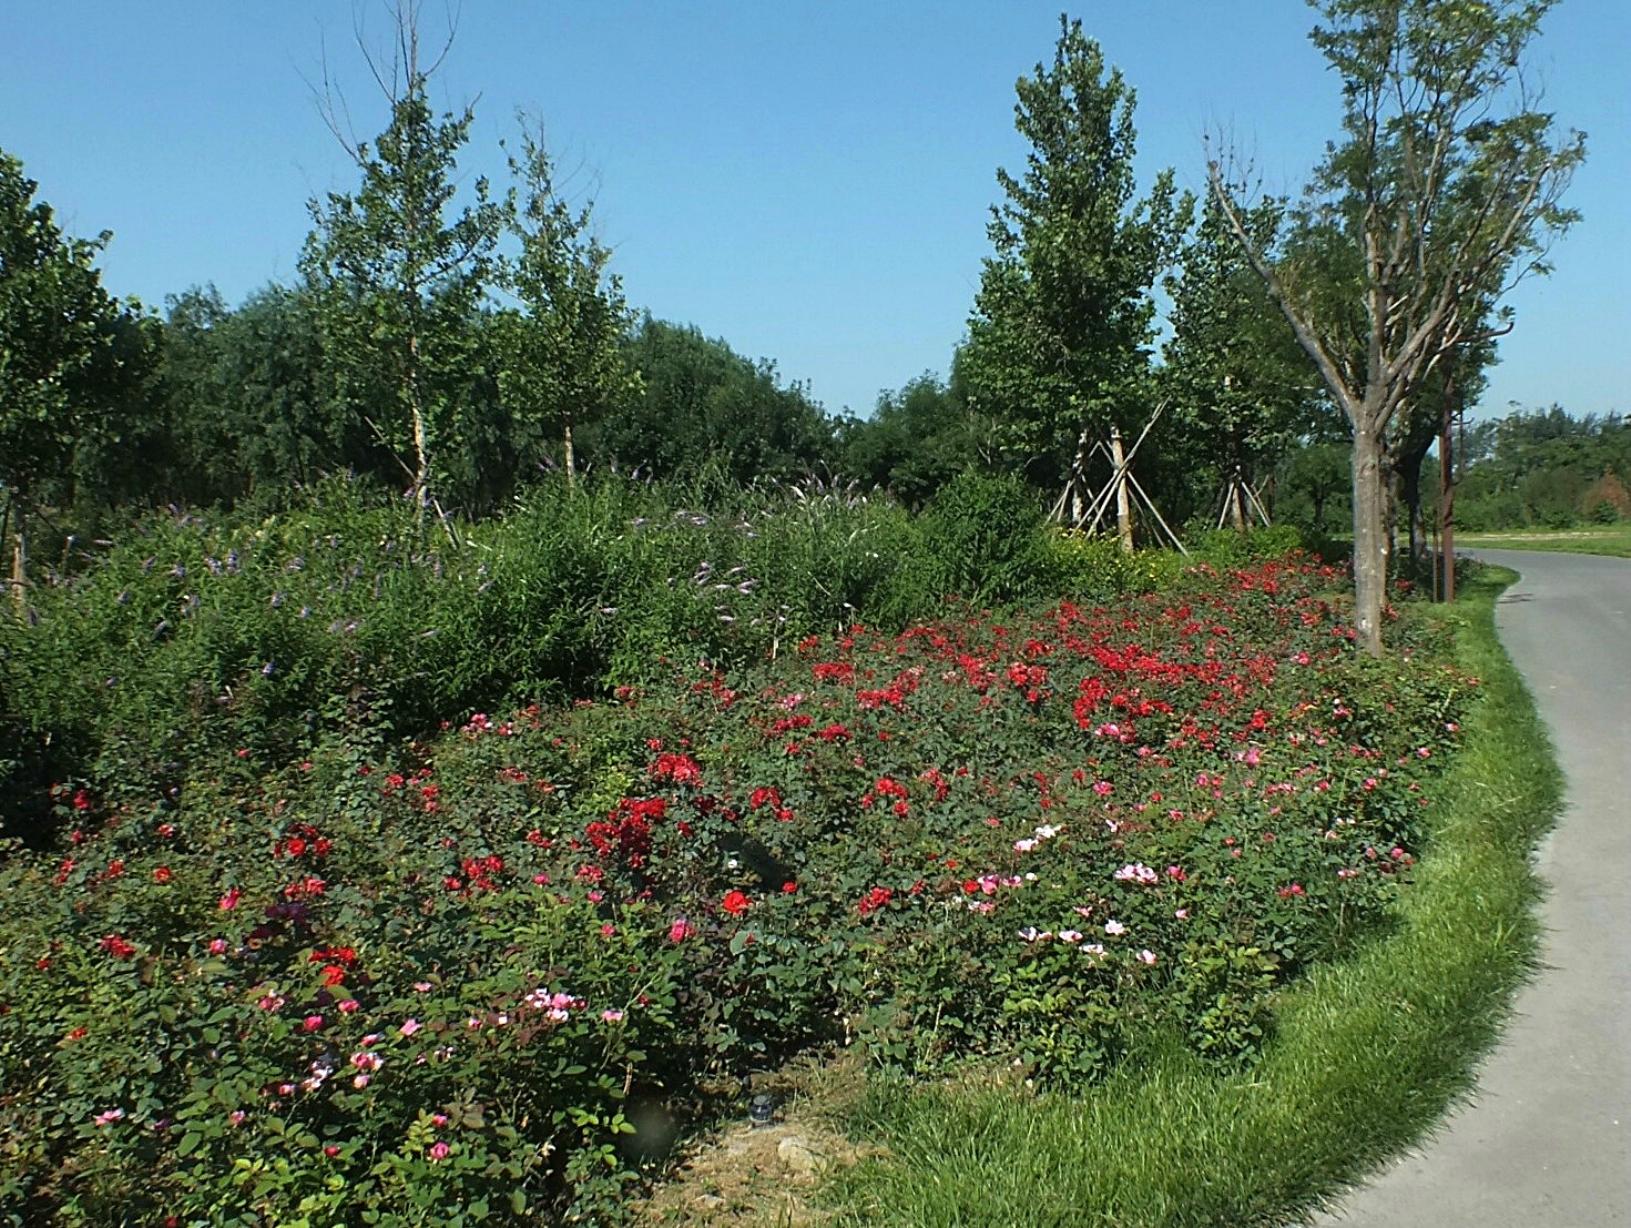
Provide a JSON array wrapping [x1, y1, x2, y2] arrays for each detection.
[[1319, 550, 1631, 1228]]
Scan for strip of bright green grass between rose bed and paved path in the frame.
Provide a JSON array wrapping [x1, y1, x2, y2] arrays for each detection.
[[824, 568, 1561, 1228]]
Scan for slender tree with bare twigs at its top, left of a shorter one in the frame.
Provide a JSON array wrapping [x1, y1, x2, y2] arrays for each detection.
[[302, 5, 506, 509]]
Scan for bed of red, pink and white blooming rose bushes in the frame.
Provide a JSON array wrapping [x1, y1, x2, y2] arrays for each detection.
[[0, 561, 1473, 1223]]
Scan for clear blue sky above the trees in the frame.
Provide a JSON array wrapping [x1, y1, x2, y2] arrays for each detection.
[[0, 0, 1631, 413]]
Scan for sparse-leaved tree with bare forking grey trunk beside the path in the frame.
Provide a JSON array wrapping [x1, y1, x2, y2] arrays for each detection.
[[1210, 0, 1585, 652]]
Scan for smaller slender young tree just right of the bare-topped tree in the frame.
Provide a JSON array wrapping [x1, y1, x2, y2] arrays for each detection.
[[497, 122, 638, 481]]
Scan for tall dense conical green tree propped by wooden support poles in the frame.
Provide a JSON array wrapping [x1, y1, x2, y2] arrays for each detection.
[[966, 18, 1191, 484]]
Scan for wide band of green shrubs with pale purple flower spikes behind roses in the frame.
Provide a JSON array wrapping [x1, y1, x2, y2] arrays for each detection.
[[0, 479, 939, 832]]
